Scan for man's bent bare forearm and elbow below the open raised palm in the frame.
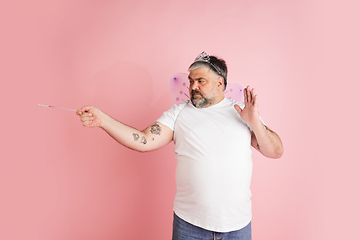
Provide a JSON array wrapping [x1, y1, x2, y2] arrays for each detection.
[[251, 123, 284, 158]]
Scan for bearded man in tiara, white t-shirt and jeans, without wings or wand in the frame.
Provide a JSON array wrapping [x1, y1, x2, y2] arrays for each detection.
[[77, 52, 283, 240]]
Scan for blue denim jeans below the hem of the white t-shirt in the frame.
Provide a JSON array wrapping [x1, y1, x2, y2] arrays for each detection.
[[172, 214, 251, 240]]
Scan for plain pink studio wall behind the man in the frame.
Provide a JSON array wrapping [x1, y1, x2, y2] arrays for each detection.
[[0, 0, 360, 240]]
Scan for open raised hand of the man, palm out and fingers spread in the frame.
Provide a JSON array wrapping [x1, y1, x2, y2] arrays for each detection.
[[234, 86, 260, 127]]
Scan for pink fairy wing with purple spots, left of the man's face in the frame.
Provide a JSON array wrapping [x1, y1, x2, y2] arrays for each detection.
[[169, 73, 190, 104]]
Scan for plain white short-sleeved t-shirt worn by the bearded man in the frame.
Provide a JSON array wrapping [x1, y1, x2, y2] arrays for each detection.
[[158, 98, 252, 232]]
